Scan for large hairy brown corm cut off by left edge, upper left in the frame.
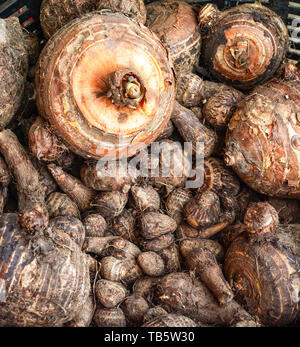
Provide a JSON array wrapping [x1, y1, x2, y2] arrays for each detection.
[[0, 17, 28, 129]]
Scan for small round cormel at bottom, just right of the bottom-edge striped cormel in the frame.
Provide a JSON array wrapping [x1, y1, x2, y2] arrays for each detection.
[[122, 294, 149, 324]]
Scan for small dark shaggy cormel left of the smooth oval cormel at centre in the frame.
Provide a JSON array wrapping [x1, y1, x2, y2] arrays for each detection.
[[111, 209, 136, 243]]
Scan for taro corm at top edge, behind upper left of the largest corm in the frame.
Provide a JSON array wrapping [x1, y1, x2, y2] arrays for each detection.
[[40, 0, 99, 39]]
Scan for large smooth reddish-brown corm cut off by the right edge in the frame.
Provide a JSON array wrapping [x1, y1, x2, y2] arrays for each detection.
[[225, 63, 300, 198]]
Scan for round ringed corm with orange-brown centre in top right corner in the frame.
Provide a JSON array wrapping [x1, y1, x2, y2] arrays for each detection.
[[198, 3, 289, 89]]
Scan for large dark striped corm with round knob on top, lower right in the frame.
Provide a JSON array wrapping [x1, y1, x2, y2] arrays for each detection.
[[224, 203, 300, 326]]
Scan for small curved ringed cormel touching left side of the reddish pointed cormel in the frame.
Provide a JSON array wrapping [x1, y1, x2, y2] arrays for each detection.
[[165, 188, 192, 225]]
